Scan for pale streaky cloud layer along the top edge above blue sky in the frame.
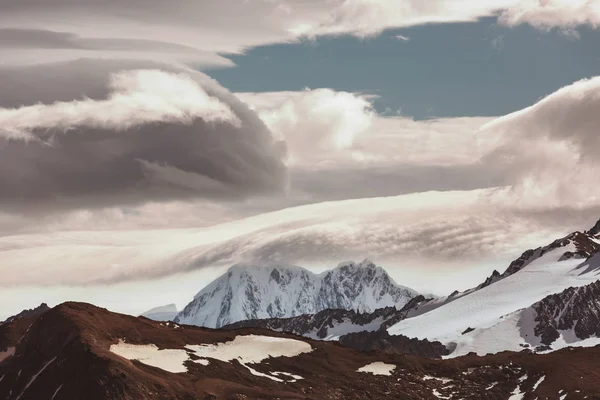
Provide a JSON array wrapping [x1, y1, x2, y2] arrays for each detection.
[[0, 0, 600, 67]]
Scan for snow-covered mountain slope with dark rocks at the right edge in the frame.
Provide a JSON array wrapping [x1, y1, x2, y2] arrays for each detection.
[[388, 223, 600, 357]]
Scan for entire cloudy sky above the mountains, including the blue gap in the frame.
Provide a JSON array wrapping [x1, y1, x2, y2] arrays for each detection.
[[0, 0, 600, 319]]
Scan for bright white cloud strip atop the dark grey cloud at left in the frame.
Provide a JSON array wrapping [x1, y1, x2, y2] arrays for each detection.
[[0, 70, 240, 140]]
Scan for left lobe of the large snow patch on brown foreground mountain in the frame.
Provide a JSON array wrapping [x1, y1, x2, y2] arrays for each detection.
[[110, 340, 189, 373]]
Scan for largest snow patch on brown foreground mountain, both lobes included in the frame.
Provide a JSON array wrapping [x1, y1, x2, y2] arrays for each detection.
[[110, 335, 313, 382]]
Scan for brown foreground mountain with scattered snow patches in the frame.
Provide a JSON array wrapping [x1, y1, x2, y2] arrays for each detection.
[[0, 303, 600, 400]]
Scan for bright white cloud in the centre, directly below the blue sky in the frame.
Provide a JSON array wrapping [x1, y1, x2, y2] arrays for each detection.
[[237, 89, 499, 169]]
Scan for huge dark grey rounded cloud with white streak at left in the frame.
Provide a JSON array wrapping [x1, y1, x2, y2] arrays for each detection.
[[0, 60, 287, 209]]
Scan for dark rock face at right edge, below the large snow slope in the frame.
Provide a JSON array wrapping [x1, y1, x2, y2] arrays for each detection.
[[532, 281, 600, 345]]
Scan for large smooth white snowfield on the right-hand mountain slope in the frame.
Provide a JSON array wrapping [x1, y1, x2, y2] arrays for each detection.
[[388, 244, 597, 357]]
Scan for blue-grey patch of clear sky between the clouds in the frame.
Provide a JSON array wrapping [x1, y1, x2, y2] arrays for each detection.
[[209, 18, 600, 119]]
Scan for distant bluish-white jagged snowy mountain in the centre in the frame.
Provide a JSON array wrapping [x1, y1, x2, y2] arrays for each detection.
[[175, 260, 418, 328]]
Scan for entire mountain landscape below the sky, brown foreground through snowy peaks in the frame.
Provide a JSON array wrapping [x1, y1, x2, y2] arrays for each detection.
[[0, 221, 600, 400]]
